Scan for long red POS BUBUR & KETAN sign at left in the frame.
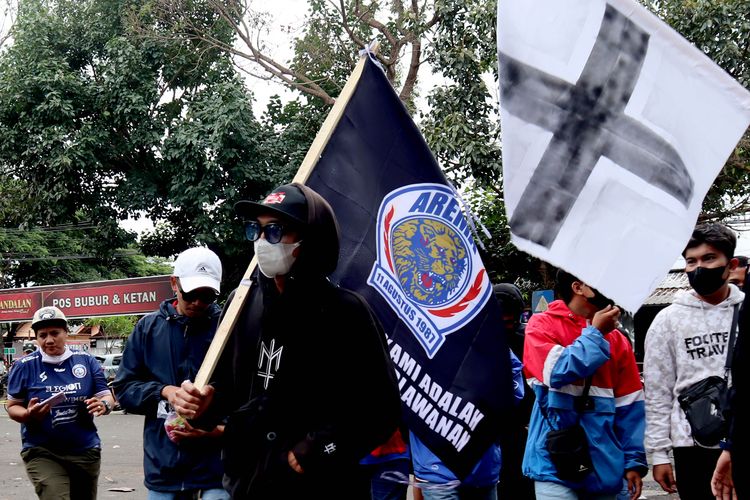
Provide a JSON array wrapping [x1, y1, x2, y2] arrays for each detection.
[[0, 276, 174, 321]]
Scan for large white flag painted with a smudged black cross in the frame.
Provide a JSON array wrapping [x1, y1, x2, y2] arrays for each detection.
[[498, 0, 750, 311]]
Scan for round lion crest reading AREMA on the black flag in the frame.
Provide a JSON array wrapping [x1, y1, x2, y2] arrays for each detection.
[[367, 184, 491, 358]]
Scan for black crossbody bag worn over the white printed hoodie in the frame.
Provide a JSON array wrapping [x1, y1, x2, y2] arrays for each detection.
[[677, 304, 740, 447]]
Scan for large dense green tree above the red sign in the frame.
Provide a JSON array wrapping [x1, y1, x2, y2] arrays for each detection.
[[0, 0, 275, 285]]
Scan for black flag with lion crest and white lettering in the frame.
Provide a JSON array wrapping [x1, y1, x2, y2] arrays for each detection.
[[306, 55, 514, 477]]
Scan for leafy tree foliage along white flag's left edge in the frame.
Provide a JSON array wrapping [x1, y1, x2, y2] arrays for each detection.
[[421, 0, 502, 188]]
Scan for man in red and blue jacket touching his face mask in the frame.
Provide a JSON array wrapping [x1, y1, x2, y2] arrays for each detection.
[[523, 270, 648, 500]]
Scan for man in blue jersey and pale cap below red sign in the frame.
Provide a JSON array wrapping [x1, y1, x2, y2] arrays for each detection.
[[6, 306, 113, 500]]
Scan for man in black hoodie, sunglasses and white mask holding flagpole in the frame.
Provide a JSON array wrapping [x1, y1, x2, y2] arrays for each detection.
[[177, 184, 400, 500]]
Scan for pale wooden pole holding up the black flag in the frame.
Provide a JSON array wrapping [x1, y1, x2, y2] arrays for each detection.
[[194, 43, 378, 389]]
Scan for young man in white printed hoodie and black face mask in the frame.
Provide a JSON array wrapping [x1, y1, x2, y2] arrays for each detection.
[[643, 224, 744, 500]]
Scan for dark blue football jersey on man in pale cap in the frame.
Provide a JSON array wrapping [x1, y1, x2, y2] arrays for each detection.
[[8, 351, 110, 453]]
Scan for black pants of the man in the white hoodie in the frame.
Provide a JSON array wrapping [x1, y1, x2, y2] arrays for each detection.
[[674, 446, 721, 500]]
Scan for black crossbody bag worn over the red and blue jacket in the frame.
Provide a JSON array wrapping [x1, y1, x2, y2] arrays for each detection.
[[539, 377, 594, 483]]
